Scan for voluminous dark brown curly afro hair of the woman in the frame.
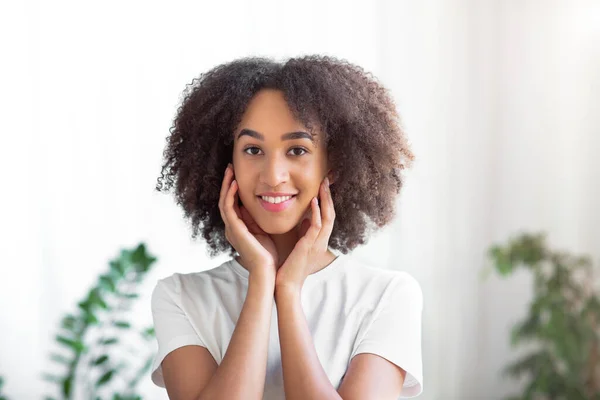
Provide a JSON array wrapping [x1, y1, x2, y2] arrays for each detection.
[[156, 55, 414, 257]]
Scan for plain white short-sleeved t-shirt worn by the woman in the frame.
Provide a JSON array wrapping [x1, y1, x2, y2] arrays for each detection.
[[151, 254, 423, 400]]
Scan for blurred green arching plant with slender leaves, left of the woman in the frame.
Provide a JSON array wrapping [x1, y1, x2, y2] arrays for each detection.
[[42, 243, 156, 400]]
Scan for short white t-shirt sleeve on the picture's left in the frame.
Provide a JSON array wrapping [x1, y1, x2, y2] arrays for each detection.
[[151, 280, 206, 387]]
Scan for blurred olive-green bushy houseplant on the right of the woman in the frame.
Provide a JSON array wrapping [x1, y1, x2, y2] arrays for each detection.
[[489, 233, 600, 400]]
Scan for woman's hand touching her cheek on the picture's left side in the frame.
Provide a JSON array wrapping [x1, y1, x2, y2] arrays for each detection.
[[219, 164, 279, 282]]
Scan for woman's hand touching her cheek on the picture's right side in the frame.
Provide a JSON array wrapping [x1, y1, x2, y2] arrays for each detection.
[[275, 178, 335, 293]]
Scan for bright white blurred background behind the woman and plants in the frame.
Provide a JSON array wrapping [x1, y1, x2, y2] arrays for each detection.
[[0, 0, 600, 400]]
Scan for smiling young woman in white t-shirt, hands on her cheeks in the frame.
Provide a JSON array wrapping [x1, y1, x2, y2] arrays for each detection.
[[152, 56, 423, 400]]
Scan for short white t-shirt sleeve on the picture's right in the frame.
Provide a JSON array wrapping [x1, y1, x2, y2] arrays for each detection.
[[352, 272, 423, 398]]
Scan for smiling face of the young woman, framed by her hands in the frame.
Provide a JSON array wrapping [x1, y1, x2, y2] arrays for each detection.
[[233, 89, 331, 234]]
